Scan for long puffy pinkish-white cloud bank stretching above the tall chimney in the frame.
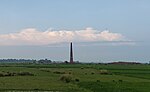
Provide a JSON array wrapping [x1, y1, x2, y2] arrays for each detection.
[[0, 28, 125, 45]]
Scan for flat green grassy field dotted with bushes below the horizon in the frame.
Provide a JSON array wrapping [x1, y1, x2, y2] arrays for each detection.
[[0, 64, 150, 92]]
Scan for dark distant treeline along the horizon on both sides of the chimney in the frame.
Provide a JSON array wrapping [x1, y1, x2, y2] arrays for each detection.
[[0, 59, 146, 65]]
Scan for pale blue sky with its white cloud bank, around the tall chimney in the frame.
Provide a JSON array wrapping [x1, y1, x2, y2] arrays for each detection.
[[0, 0, 150, 62]]
